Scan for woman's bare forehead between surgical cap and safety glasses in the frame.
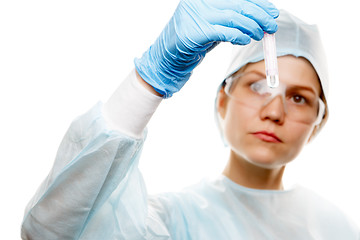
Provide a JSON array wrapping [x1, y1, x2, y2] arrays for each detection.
[[242, 55, 321, 95]]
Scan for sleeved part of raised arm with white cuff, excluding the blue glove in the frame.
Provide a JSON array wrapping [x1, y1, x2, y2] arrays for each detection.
[[22, 71, 162, 239]]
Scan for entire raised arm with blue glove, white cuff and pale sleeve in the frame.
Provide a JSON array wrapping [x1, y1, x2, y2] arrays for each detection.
[[22, 0, 279, 239]]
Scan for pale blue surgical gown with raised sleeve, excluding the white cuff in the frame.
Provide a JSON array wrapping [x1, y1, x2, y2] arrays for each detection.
[[21, 71, 360, 240]]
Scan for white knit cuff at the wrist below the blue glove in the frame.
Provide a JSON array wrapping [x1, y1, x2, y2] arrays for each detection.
[[102, 69, 163, 139]]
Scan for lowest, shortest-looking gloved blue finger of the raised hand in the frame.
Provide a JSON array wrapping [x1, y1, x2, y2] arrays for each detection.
[[208, 25, 251, 45]]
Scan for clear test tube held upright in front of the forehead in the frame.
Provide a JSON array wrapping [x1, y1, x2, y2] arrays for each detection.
[[263, 32, 279, 88]]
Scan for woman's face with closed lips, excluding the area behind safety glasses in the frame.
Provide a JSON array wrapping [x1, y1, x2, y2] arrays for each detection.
[[218, 56, 321, 169]]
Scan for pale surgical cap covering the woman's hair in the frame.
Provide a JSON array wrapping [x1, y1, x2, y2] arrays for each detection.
[[226, 10, 329, 100]]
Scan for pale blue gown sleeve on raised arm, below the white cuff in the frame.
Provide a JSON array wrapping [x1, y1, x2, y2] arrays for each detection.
[[21, 103, 170, 240]]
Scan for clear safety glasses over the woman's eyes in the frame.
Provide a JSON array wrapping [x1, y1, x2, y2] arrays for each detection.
[[225, 72, 325, 124]]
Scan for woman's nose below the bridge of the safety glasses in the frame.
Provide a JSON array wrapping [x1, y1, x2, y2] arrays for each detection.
[[260, 95, 286, 125]]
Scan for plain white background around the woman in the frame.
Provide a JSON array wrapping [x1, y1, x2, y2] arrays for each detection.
[[0, 0, 360, 239]]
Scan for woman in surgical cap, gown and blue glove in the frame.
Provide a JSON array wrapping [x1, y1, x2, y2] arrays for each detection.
[[22, 0, 360, 240]]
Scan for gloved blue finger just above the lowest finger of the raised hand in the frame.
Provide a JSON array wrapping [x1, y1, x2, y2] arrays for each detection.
[[208, 10, 264, 40]]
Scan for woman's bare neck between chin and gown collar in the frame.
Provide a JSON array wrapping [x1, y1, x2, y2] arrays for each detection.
[[223, 152, 285, 190]]
